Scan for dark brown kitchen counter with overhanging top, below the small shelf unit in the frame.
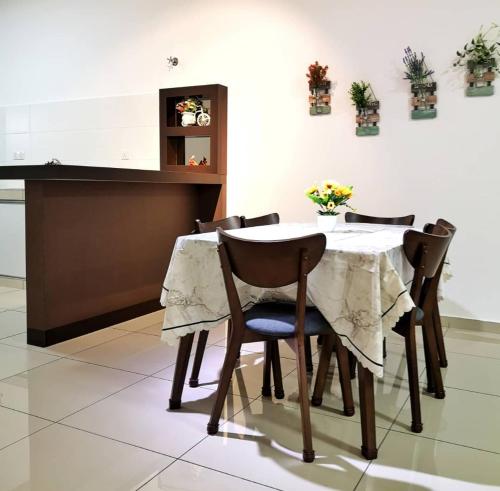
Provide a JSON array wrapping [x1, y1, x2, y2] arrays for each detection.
[[0, 166, 226, 346]]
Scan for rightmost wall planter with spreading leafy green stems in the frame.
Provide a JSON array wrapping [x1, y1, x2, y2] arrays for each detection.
[[453, 24, 500, 97]]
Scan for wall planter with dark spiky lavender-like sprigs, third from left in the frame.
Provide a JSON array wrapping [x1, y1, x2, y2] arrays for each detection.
[[403, 47, 437, 119]]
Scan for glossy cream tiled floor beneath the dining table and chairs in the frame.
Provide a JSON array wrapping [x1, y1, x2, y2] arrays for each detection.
[[0, 289, 500, 491]]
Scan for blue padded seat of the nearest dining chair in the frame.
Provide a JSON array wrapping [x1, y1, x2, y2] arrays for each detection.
[[244, 302, 332, 338]]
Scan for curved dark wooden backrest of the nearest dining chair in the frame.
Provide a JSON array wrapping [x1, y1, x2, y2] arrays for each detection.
[[217, 229, 326, 288]]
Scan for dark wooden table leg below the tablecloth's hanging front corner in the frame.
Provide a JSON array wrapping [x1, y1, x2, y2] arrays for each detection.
[[358, 363, 378, 460]]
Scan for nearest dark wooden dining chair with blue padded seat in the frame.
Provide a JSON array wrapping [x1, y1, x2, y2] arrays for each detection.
[[207, 230, 354, 462]]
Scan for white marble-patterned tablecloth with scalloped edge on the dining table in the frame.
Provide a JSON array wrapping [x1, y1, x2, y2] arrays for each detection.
[[161, 224, 414, 377]]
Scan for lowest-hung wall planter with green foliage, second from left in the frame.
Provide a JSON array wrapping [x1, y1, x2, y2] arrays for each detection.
[[349, 81, 380, 136]]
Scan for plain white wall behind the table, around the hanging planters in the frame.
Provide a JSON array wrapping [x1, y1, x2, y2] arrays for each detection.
[[0, 0, 500, 321]]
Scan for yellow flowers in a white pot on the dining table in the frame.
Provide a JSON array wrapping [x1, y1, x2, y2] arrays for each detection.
[[306, 180, 353, 232]]
